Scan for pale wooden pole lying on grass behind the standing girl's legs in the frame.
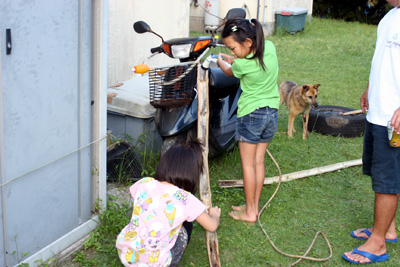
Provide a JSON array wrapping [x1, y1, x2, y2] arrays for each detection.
[[219, 159, 362, 188]]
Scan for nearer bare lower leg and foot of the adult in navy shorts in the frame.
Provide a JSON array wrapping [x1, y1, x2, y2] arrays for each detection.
[[345, 193, 398, 263]]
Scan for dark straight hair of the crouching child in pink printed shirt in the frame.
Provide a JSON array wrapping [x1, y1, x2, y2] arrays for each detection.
[[154, 140, 203, 194]]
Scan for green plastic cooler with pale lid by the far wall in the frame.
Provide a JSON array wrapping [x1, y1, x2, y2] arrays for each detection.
[[275, 7, 307, 34]]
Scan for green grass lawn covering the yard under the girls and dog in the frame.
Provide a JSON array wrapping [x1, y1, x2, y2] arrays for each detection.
[[68, 18, 400, 267]]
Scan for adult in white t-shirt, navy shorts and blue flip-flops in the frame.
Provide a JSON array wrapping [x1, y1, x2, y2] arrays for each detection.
[[343, 0, 400, 264]]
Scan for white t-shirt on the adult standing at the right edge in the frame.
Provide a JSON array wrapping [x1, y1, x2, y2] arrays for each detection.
[[367, 7, 400, 126]]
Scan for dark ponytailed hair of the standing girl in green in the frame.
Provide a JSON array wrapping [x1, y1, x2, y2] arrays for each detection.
[[222, 18, 266, 70]]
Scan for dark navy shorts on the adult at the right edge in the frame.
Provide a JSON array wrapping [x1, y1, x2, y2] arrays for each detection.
[[363, 122, 400, 194]]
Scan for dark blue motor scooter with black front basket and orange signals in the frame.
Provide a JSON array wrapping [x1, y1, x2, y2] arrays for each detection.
[[133, 11, 245, 156]]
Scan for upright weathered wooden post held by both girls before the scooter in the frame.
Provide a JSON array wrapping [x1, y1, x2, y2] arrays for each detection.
[[197, 65, 221, 267]]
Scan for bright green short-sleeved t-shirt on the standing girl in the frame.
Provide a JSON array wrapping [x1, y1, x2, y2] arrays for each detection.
[[232, 41, 280, 118]]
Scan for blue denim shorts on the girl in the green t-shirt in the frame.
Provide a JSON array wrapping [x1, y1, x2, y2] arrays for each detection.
[[236, 107, 278, 144]]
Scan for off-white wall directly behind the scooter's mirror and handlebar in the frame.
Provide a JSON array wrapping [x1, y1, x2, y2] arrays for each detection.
[[108, 0, 191, 86]]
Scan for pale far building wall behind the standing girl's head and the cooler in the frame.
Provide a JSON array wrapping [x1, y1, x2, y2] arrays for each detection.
[[190, 0, 313, 35]]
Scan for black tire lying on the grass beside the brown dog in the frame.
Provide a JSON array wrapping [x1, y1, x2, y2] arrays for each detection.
[[308, 105, 366, 137]]
